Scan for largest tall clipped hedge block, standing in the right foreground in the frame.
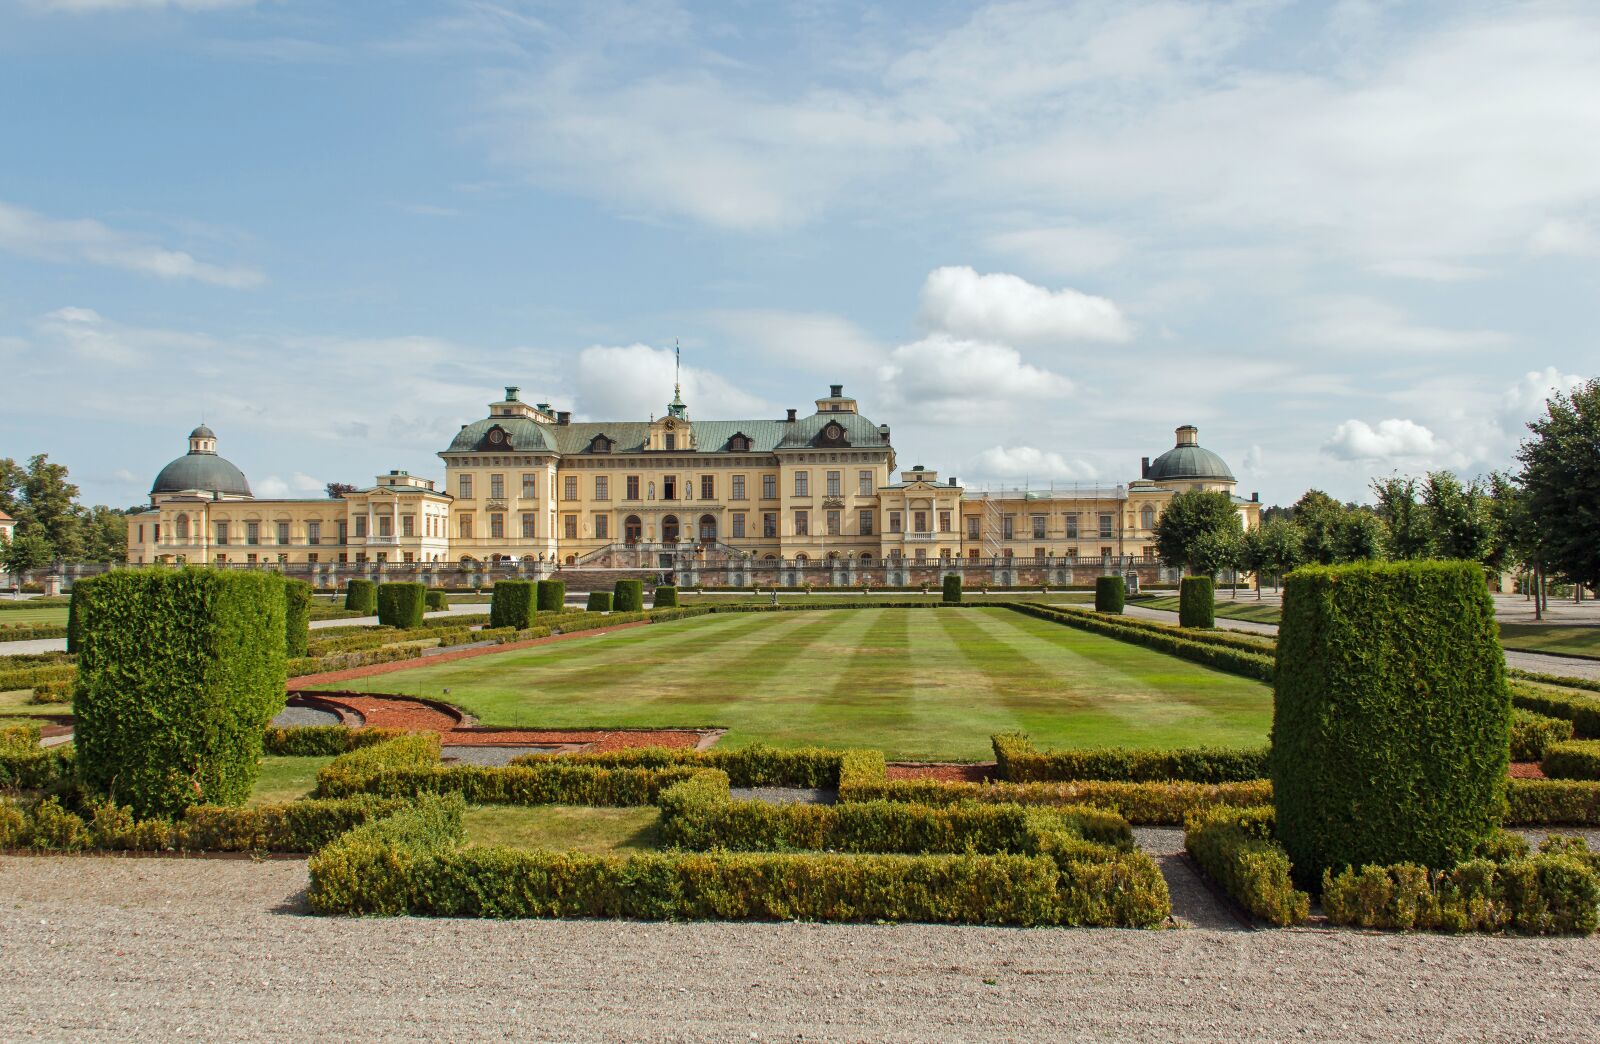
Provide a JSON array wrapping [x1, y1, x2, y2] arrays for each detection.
[[1269, 562, 1510, 887]]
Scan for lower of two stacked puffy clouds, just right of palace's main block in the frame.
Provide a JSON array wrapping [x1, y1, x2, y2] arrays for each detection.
[[878, 333, 1072, 404]]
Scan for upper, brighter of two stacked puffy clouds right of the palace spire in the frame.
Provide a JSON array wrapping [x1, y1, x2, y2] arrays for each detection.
[[922, 264, 1133, 344]]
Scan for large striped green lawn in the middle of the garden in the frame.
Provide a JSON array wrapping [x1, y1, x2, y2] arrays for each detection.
[[305, 608, 1272, 761]]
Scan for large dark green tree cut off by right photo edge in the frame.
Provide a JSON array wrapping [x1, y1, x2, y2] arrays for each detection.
[[1517, 379, 1600, 588]]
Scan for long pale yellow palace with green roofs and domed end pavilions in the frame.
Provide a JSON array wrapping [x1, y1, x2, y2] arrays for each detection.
[[128, 384, 1259, 583]]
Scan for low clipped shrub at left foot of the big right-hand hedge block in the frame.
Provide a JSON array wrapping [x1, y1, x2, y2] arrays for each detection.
[[1184, 807, 1310, 926]]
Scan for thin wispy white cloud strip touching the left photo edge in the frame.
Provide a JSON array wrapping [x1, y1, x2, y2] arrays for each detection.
[[0, 203, 266, 290]]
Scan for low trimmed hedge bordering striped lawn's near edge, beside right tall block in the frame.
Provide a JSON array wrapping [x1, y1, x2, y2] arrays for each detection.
[[990, 733, 1267, 783]]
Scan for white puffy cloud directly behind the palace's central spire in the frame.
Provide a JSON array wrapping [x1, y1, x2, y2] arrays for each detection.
[[576, 344, 779, 421]]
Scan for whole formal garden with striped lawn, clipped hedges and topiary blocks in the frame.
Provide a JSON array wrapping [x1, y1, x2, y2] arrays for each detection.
[[0, 562, 1600, 935]]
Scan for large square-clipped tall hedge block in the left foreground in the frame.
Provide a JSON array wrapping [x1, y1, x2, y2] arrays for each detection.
[[74, 568, 285, 817]]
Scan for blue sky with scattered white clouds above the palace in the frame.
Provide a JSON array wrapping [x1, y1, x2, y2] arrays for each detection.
[[0, 0, 1600, 506]]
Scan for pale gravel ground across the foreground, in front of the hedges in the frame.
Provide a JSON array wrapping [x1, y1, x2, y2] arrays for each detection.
[[0, 857, 1600, 1041]]
